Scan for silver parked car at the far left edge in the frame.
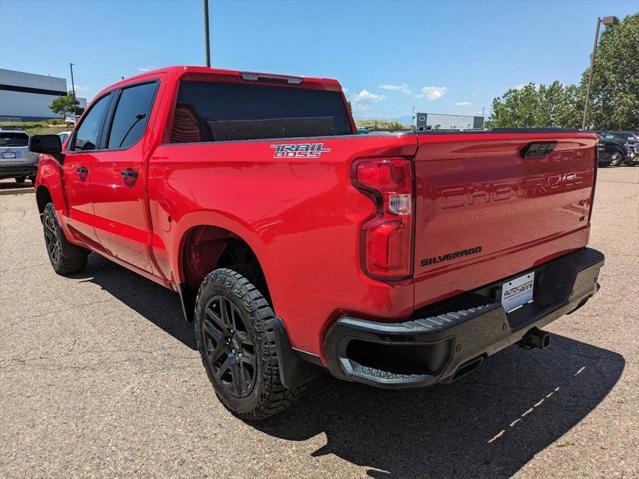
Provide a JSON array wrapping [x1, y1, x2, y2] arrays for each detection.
[[0, 130, 40, 183]]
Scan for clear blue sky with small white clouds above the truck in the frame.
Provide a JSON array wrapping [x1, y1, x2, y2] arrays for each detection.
[[0, 0, 639, 118]]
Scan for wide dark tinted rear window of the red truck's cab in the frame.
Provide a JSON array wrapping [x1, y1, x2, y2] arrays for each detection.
[[171, 80, 353, 143]]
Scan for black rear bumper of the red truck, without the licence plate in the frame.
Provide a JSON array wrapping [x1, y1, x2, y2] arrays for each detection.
[[324, 248, 604, 388]]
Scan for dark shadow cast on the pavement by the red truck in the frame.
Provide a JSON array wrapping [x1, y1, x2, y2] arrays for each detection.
[[78, 255, 625, 479]]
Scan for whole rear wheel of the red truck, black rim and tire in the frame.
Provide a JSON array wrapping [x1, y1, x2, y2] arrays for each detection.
[[195, 268, 301, 420]]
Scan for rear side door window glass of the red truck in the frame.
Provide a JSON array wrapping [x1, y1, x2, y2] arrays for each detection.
[[107, 82, 157, 150]]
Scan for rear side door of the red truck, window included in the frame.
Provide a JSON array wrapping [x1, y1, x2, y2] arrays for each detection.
[[91, 80, 159, 272]]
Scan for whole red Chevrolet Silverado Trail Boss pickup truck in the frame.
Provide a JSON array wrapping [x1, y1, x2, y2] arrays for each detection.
[[30, 67, 604, 419]]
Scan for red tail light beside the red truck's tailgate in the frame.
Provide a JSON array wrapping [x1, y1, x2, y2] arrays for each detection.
[[353, 158, 413, 280]]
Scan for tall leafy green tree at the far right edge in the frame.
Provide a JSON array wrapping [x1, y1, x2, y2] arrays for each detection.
[[580, 13, 639, 130]]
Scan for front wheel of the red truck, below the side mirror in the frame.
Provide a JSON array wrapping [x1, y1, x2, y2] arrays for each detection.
[[42, 203, 89, 276]]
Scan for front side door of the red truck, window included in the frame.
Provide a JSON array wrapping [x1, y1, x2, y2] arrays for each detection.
[[62, 93, 112, 244]]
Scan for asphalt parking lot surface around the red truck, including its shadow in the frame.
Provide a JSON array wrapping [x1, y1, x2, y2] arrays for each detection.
[[0, 167, 639, 478]]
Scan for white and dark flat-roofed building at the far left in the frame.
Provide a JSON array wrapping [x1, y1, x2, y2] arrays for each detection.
[[0, 68, 87, 121]]
